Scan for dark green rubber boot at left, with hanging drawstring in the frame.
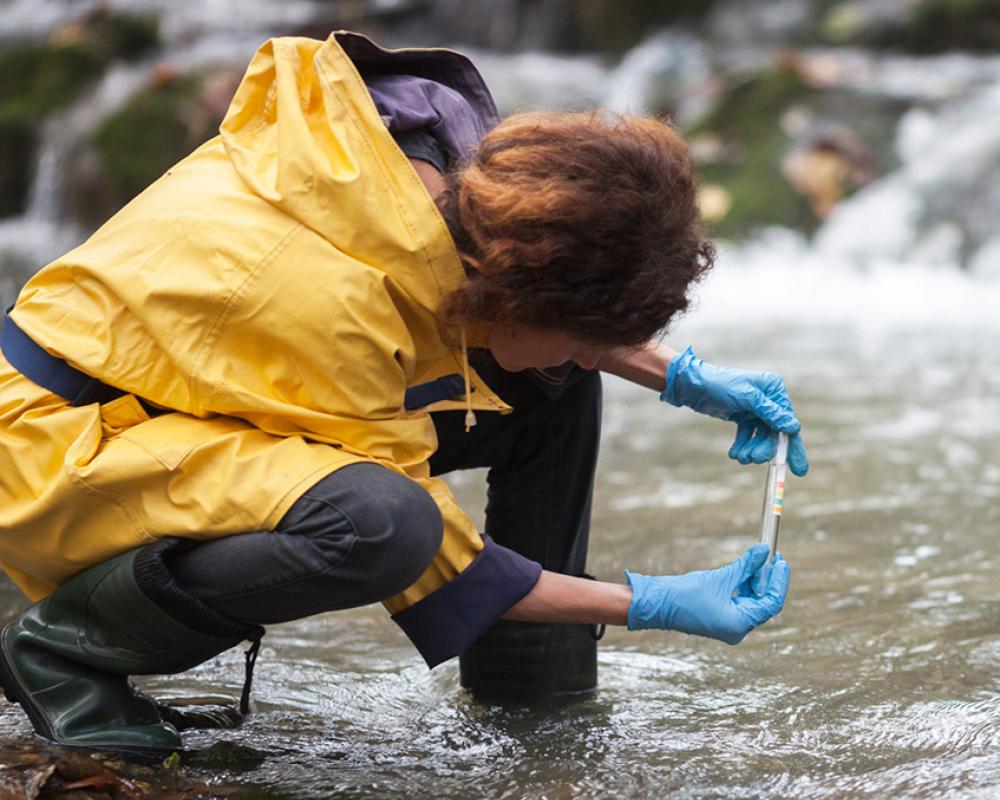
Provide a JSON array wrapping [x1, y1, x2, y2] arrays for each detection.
[[0, 539, 263, 757]]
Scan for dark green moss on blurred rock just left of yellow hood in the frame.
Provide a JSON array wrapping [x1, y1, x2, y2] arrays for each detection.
[[93, 76, 219, 207]]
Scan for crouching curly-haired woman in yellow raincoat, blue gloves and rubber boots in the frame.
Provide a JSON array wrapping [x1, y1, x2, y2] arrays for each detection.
[[0, 33, 806, 753]]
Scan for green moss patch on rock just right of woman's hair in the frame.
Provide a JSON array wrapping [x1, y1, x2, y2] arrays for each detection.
[[691, 69, 818, 237]]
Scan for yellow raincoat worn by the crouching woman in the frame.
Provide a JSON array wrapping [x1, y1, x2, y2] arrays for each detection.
[[0, 29, 509, 656]]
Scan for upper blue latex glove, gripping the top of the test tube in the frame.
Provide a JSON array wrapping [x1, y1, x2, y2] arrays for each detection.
[[660, 347, 809, 476]]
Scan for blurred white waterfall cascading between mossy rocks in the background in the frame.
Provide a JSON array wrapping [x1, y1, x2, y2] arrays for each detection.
[[0, 0, 1000, 315]]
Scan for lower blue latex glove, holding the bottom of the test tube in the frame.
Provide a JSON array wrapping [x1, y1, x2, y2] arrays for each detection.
[[625, 543, 790, 644]]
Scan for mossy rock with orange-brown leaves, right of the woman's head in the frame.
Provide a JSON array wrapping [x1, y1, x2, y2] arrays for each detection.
[[689, 51, 905, 238]]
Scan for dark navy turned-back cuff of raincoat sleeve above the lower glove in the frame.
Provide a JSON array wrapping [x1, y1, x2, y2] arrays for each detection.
[[392, 536, 542, 668]]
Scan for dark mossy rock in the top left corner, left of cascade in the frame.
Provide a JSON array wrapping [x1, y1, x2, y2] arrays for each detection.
[[0, 13, 159, 217]]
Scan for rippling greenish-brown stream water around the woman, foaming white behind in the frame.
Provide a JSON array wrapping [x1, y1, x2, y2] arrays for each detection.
[[0, 3, 1000, 800]]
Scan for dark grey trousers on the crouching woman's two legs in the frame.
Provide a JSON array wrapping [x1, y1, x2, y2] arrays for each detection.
[[170, 350, 601, 625]]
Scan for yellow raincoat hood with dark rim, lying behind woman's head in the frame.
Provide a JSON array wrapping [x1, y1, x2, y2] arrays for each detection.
[[220, 31, 497, 318]]
